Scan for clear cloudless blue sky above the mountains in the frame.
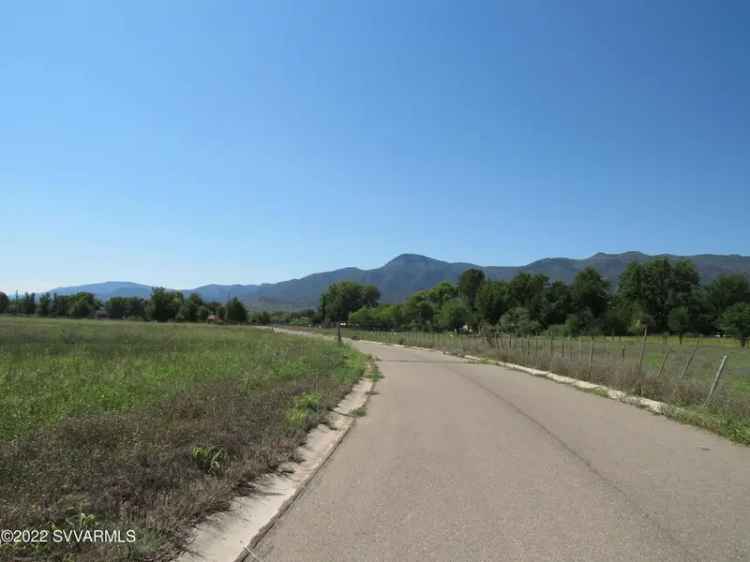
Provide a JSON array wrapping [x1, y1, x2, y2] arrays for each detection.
[[0, 0, 750, 291]]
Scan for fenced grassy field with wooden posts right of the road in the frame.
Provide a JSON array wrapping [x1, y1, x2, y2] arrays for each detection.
[[292, 328, 750, 444]]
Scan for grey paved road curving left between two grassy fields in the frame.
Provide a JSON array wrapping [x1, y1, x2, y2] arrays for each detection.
[[256, 343, 750, 562]]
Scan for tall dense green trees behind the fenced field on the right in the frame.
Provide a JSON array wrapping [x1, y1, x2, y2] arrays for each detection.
[[313, 258, 750, 346]]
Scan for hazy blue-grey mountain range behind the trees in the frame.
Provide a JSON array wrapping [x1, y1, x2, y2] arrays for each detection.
[[50, 252, 750, 310]]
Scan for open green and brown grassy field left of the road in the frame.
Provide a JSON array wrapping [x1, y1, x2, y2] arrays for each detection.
[[0, 316, 366, 560]]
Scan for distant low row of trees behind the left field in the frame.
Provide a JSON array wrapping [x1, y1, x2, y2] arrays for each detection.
[[0, 287, 272, 324]]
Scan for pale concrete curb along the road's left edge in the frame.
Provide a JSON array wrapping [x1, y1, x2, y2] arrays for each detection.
[[177, 366, 375, 562]]
